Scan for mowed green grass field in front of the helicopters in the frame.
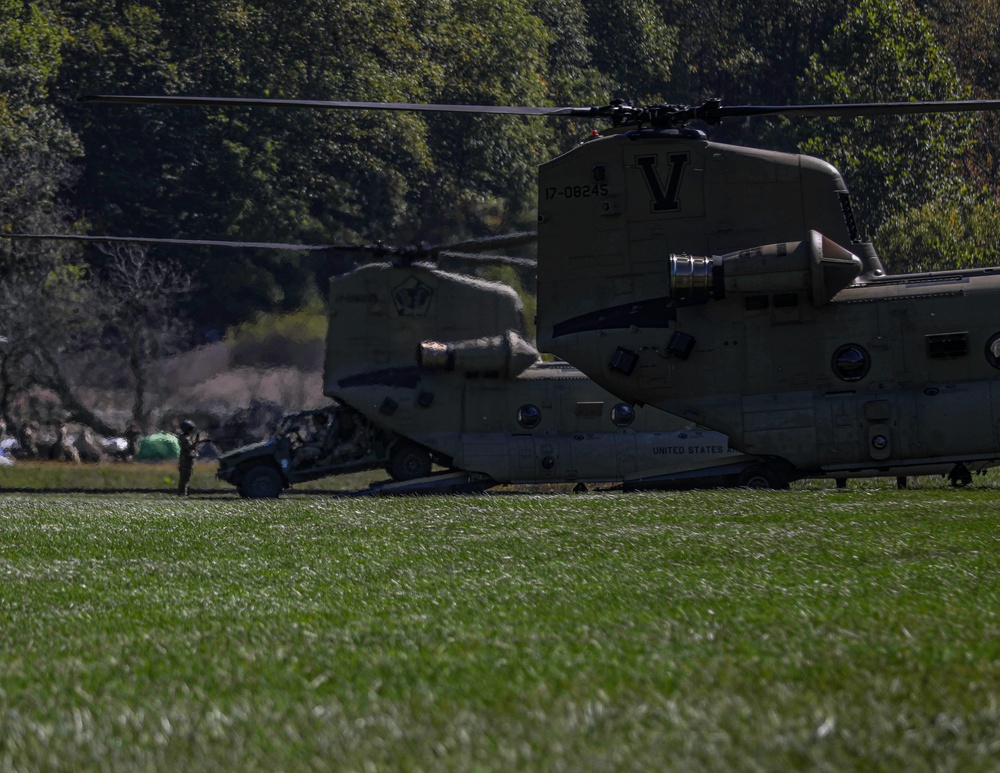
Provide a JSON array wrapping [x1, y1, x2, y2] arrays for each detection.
[[0, 484, 1000, 771]]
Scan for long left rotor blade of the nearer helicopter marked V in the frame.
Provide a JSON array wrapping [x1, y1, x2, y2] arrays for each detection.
[[78, 94, 603, 117]]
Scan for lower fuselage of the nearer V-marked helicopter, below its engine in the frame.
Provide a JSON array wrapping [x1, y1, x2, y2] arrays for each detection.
[[559, 249, 1000, 474]]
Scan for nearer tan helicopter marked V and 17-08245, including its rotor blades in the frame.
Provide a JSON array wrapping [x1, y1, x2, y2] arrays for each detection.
[[9, 96, 1000, 487]]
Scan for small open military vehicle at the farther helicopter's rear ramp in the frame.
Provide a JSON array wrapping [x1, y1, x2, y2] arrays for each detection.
[[216, 403, 436, 499]]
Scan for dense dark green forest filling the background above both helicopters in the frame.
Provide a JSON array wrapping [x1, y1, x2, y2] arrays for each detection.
[[0, 0, 1000, 328]]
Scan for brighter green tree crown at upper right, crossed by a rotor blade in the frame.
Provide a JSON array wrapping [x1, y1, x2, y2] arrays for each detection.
[[802, 0, 970, 235]]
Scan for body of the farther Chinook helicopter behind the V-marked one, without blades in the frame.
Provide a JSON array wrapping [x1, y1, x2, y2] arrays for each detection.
[[312, 243, 755, 489]]
